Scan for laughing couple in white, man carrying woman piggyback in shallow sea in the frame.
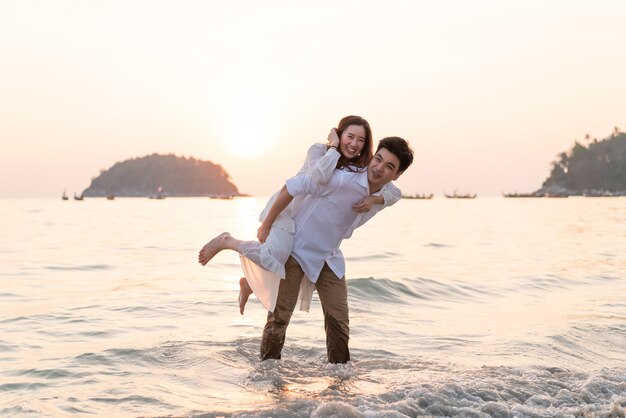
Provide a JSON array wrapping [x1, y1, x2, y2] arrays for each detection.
[[198, 116, 413, 363]]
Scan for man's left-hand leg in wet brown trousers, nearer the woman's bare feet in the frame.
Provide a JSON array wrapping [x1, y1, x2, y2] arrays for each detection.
[[261, 257, 304, 360]]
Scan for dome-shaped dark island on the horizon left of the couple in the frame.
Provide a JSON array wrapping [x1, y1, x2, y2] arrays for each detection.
[[83, 154, 241, 197]]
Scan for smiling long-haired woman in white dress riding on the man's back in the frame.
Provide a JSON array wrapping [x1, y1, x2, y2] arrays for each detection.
[[198, 116, 401, 314]]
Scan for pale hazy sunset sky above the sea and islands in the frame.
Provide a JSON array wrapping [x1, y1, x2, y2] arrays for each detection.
[[0, 0, 626, 197]]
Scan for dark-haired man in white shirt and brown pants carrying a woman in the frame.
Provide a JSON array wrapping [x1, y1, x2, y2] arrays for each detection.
[[258, 137, 413, 363]]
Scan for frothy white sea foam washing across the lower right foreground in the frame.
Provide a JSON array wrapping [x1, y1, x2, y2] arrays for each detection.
[[219, 365, 626, 418]]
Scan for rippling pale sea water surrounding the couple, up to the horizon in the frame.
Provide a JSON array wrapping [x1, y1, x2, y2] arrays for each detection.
[[0, 197, 626, 417]]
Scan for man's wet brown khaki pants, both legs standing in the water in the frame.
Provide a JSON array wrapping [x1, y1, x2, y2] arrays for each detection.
[[261, 256, 350, 363]]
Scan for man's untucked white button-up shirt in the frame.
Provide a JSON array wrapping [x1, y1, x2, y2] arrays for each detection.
[[286, 169, 386, 283]]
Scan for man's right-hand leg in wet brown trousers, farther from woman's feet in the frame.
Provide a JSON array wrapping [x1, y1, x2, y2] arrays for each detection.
[[315, 264, 350, 363]]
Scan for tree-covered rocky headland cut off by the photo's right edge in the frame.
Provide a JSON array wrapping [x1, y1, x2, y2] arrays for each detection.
[[533, 128, 626, 196]]
